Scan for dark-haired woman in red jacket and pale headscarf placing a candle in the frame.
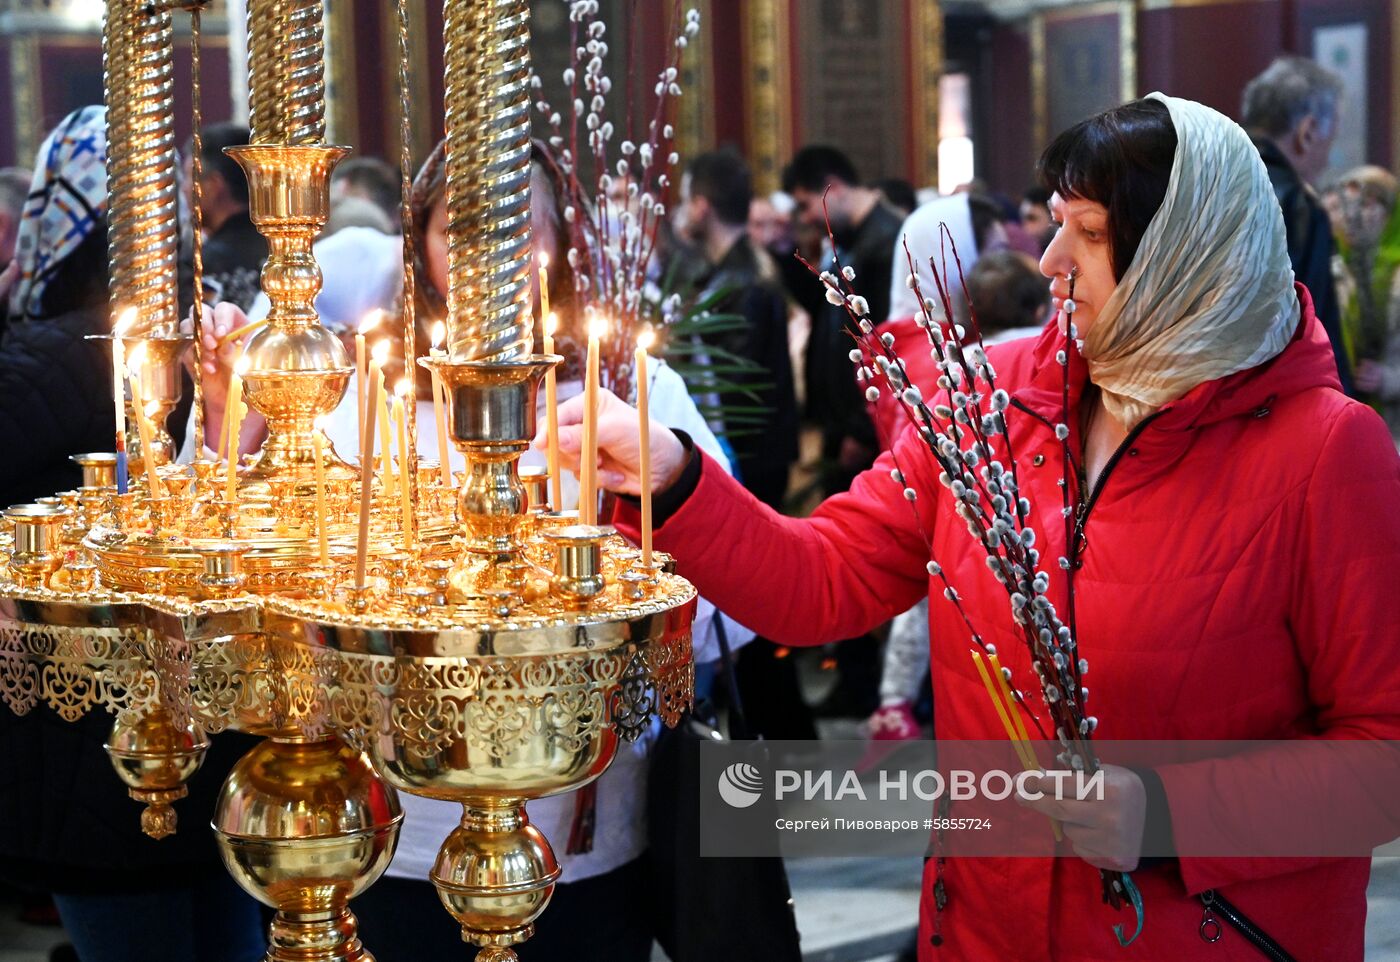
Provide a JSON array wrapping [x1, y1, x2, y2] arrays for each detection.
[[543, 94, 1400, 962]]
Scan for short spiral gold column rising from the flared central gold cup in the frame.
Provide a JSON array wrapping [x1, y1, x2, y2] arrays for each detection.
[[248, 0, 326, 147]]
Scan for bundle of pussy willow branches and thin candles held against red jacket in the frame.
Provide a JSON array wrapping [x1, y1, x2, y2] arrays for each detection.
[[804, 225, 1141, 941]]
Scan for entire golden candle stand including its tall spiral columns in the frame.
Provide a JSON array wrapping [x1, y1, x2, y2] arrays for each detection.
[[0, 0, 696, 962]]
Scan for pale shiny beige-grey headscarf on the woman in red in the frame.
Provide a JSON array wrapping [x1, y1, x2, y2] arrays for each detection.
[[1084, 94, 1299, 427]]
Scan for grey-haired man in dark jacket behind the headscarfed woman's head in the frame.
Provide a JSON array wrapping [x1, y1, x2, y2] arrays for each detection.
[[1240, 56, 1354, 395]]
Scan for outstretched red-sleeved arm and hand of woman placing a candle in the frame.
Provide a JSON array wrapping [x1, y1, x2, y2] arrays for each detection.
[[536, 392, 939, 646]]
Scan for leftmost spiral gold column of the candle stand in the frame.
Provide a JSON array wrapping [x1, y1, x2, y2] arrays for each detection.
[[102, 0, 179, 336]]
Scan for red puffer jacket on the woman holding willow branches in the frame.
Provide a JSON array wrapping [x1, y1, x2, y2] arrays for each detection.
[[617, 287, 1400, 962]]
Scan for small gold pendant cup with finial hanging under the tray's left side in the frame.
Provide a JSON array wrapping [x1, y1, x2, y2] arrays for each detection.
[[102, 709, 209, 839]]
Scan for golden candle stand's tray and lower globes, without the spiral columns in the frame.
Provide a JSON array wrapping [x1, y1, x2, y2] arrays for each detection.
[[0, 383, 694, 959]]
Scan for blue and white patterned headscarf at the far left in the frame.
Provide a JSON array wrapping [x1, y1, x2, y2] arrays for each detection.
[[10, 106, 106, 322]]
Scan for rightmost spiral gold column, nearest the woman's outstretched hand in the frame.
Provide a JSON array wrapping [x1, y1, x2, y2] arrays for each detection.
[[442, 0, 532, 361]]
